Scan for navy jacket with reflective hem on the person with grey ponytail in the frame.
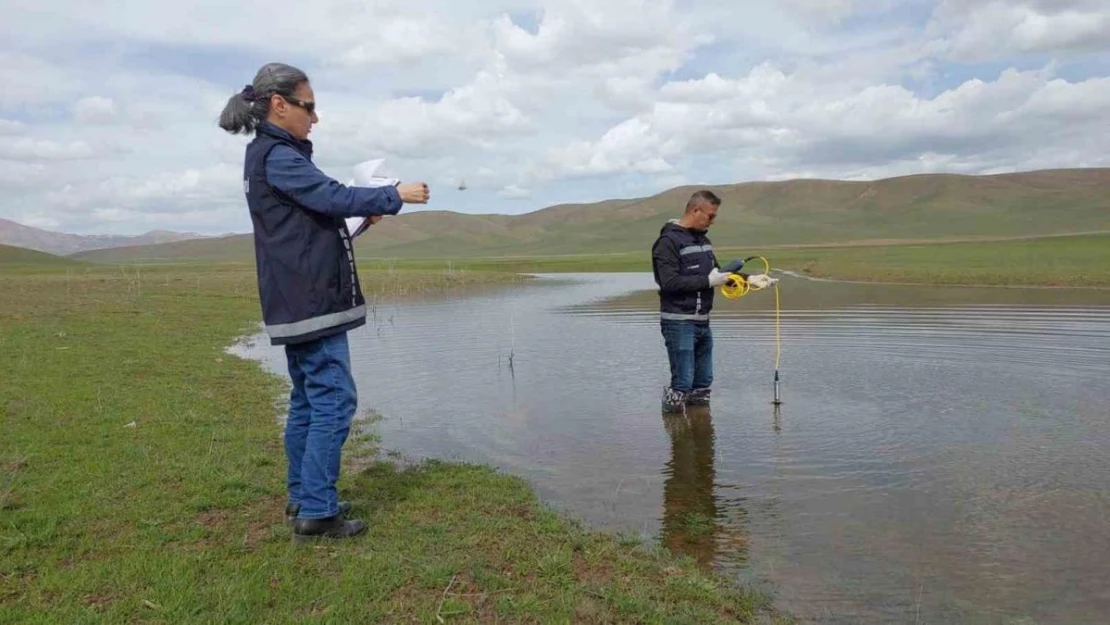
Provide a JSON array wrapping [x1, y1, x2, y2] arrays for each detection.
[[243, 122, 402, 345]]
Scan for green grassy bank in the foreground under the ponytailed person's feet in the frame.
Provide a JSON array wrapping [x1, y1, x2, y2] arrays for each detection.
[[0, 265, 786, 623]]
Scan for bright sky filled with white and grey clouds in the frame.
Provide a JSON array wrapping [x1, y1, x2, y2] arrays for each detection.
[[0, 0, 1110, 234]]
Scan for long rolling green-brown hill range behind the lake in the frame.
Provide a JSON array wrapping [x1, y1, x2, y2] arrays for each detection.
[[73, 169, 1110, 262]]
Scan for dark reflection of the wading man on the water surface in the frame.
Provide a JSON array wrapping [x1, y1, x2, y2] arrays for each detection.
[[663, 407, 719, 568]]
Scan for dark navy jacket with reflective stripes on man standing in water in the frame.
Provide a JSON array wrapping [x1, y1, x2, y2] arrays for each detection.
[[652, 220, 719, 323]]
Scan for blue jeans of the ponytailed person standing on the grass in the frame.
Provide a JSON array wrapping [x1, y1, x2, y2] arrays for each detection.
[[285, 332, 359, 518]]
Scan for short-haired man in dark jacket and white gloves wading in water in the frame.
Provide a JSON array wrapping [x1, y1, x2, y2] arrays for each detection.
[[652, 190, 778, 412]]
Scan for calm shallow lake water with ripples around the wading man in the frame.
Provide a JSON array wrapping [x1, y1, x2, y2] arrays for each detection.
[[236, 274, 1110, 623]]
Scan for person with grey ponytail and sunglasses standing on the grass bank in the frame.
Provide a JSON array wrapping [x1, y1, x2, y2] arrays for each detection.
[[220, 63, 428, 541]]
